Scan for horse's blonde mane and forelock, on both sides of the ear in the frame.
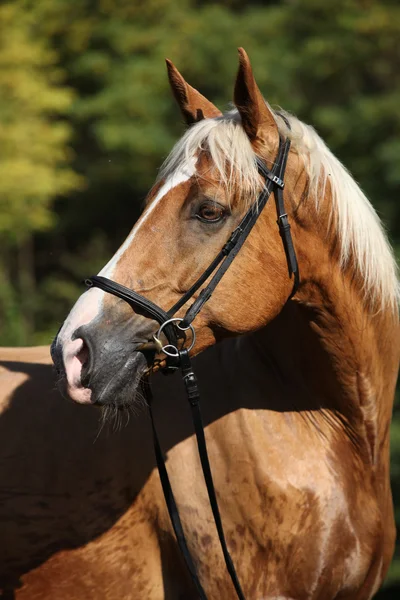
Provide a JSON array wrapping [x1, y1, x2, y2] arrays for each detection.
[[159, 109, 400, 311]]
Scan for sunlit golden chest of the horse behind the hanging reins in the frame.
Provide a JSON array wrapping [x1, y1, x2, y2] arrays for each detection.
[[147, 415, 381, 599]]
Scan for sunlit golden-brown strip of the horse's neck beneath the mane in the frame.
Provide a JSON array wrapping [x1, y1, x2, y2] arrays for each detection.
[[285, 158, 400, 412]]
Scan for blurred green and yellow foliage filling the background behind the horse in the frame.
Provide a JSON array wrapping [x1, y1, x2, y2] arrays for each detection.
[[0, 0, 400, 592]]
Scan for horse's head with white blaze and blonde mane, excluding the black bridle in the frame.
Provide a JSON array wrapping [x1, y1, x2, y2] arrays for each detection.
[[52, 49, 397, 405]]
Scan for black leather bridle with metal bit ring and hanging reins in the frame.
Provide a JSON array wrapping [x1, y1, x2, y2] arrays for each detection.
[[85, 138, 300, 600]]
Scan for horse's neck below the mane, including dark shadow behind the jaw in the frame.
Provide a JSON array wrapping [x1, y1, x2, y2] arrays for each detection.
[[253, 216, 400, 462]]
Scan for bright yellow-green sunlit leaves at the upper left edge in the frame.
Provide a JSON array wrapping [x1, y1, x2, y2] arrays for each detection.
[[0, 1, 79, 240]]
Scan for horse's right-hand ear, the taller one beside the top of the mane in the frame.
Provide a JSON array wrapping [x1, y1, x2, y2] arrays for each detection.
[[234, 48, 277, 141]]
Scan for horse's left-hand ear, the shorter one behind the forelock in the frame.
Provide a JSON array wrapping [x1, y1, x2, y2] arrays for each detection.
[[166, 58, 222, 125]]
